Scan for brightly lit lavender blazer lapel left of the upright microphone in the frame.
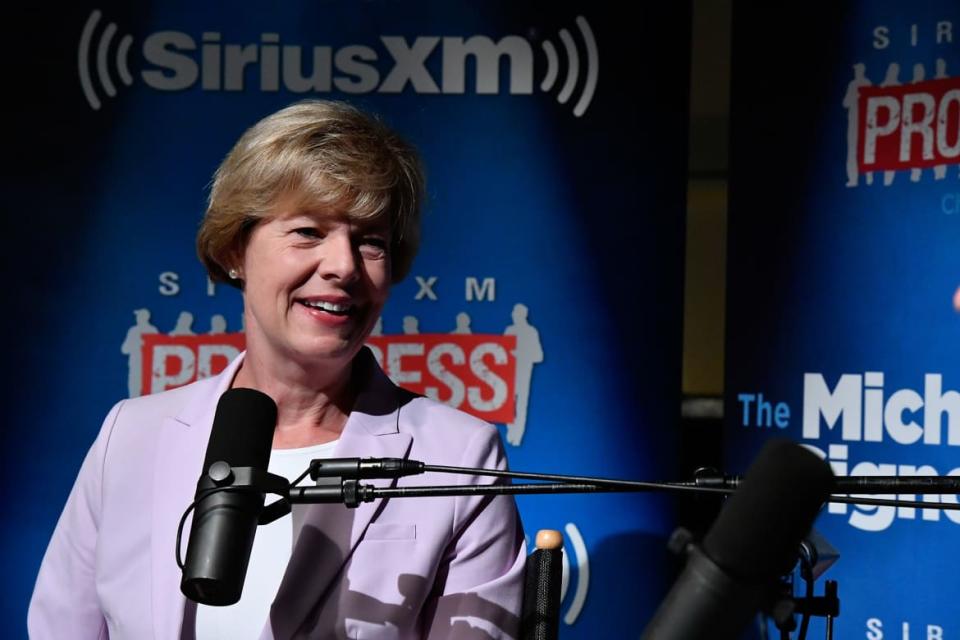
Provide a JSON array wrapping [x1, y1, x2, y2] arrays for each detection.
[[151, 355, 243, 640]]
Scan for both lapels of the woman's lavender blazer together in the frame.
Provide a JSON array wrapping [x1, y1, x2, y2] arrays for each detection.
[[151, 348, 411, 640]]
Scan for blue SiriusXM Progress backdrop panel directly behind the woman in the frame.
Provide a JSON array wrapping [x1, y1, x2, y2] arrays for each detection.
[[7, 0, 690, 638]]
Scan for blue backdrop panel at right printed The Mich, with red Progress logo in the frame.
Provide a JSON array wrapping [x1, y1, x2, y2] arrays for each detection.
[[726, 1, 960, 640]]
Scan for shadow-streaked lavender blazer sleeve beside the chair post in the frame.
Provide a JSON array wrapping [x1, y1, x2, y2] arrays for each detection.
[[424, 425, 526, 640]]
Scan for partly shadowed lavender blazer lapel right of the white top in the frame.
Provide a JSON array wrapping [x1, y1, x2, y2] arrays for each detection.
[[274, 349, 412, 640]]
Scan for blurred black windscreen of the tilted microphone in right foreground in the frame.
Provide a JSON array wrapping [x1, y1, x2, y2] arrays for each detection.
[[703, 440, 833, 583]]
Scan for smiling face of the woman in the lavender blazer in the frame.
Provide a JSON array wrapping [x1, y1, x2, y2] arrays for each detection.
[[242, 197, 390, 366]]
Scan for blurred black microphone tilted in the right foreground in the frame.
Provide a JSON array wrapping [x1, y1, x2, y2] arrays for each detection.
[[642, 440, 833, 640]]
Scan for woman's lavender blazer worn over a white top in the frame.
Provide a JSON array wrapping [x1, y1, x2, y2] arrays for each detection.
[[27, 349, 526, 640]]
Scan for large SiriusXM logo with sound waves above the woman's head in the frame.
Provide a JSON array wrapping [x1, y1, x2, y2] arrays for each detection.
[[77, 10, 599, 117]]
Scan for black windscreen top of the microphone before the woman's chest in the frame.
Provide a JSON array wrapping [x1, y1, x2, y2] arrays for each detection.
[[203, 388, 277, 472]]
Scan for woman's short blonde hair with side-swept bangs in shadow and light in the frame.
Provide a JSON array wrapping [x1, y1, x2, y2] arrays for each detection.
[[197, 100, 424, 286]]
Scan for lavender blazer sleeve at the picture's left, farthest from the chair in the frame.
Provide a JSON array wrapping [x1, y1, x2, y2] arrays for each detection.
[[27, 402, 122, 640]]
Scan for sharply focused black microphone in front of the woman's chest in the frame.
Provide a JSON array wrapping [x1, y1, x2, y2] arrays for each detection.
[[180, 389, 277, 606]]
